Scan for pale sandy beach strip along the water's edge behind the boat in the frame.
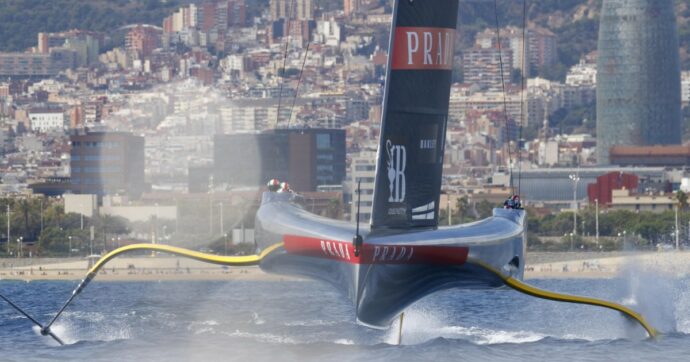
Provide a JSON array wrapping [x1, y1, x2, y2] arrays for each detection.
[[0, 251, 690, 281]]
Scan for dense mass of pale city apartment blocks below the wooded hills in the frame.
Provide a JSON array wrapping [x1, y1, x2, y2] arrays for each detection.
[[0, 0, 690, 215]]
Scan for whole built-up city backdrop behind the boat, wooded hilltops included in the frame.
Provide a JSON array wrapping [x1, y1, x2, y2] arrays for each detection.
[[0, 0, 690, 255]]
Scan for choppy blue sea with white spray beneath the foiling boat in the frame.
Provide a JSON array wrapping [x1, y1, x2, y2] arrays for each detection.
[[0, 275, 690, 361]]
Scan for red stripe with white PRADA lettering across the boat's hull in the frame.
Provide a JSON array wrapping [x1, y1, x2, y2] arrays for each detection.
[[283, 235, 469, 265]]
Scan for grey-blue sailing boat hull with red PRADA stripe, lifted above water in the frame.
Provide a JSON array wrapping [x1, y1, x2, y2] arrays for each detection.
[[256, 193, 525, 328]]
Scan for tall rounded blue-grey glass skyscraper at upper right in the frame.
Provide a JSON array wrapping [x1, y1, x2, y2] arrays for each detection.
[[597, 0, 681, 164]]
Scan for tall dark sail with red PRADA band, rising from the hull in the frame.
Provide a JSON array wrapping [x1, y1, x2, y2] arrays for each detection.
[[371, 0, 458, 230]]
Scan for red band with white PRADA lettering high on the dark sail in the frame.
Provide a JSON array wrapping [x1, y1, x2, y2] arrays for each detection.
[[391, 27, 455, 70]]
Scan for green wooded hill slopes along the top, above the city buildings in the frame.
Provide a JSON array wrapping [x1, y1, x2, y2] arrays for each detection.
[[0, 0, 690, 73]]
